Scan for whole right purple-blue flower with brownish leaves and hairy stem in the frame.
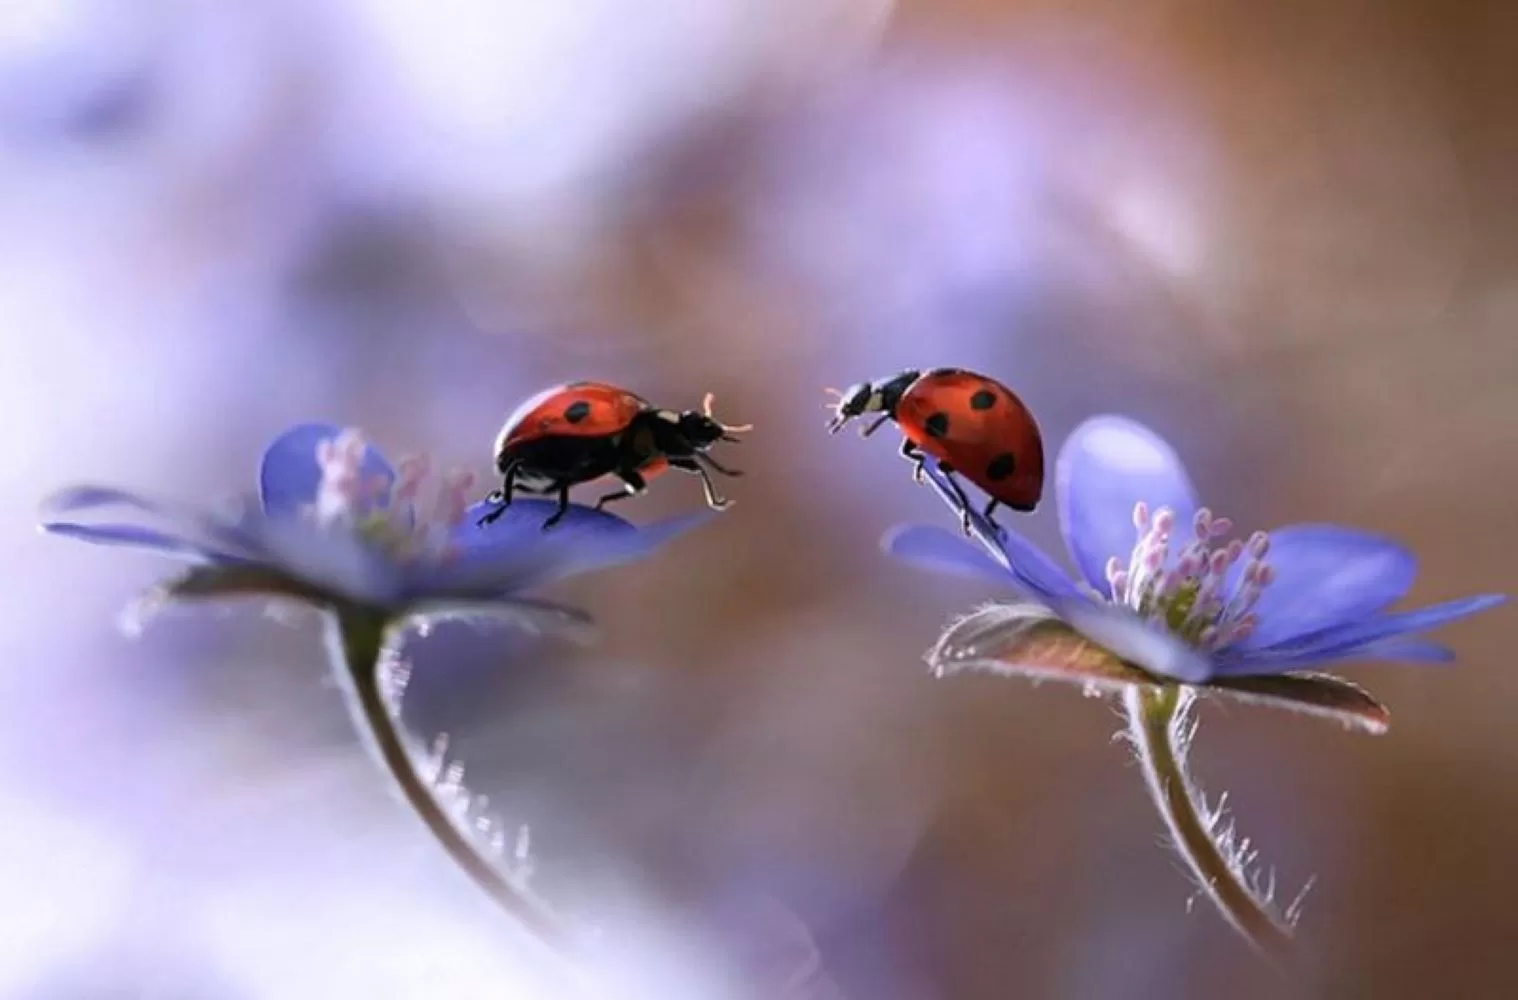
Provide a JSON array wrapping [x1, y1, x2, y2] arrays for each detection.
[[882, 416, 1504, 956]]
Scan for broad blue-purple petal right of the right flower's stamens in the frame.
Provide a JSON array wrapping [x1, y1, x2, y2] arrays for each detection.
[[1230, 525, 1418, 649]]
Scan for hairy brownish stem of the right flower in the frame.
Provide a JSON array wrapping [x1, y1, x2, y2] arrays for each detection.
[[1123, 684, 1292, 961]]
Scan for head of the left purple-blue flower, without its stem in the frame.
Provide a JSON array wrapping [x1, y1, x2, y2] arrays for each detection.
[[43, 423, 707, 631]]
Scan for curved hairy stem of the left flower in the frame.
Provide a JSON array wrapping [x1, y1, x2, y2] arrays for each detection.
[[328, 612, 575, 961]]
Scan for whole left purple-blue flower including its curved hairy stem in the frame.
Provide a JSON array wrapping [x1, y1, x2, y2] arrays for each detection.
[[41, 423, 709, 950]]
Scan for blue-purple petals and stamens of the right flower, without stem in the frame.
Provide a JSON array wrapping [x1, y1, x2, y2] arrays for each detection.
[[882, 416, 1504, 684]]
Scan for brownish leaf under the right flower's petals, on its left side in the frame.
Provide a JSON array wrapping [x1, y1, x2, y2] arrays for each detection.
[[926, 604, 1164, 692]]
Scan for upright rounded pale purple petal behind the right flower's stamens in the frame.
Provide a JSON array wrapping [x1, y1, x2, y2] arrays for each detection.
[[1055, 416, 1196, 596]]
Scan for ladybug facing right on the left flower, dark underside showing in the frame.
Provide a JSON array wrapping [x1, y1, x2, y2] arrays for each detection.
[[480, 382, 751, 528]]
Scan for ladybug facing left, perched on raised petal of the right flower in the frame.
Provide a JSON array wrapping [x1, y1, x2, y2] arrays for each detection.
[[827, 369, 1044, 533]]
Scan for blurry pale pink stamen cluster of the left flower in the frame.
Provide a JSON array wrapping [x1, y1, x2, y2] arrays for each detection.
[[310, 429, 475, 560]]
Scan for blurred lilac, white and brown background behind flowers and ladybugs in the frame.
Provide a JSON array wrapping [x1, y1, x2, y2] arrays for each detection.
[[0, 0, 1518, 1000]]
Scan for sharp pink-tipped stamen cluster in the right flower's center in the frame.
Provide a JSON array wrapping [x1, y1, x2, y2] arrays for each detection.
[[1107, 502, 1275, 649]]
